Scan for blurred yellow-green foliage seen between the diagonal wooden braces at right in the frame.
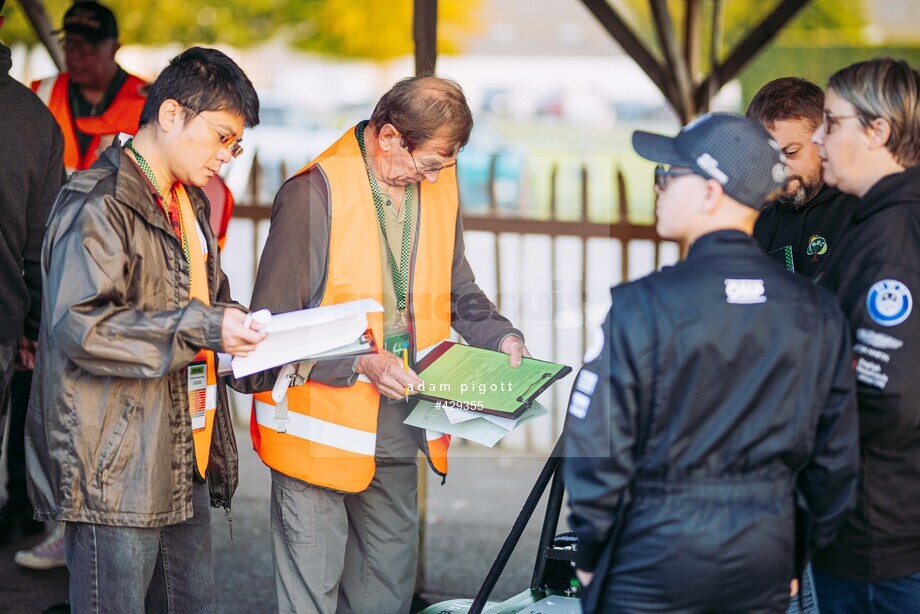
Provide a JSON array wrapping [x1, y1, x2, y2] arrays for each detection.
[[608, 0, 867, 70]]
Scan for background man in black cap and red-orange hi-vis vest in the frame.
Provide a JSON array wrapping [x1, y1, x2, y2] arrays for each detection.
[[32, 2, 146, 174]]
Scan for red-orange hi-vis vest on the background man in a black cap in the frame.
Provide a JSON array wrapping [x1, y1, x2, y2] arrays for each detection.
[[32, 73, 146, 175]]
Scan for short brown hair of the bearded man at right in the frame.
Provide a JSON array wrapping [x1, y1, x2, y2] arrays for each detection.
[[745, 77, 824, 130]]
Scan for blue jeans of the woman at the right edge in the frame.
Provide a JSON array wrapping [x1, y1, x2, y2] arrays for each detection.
[[815, 571, 920, 614]]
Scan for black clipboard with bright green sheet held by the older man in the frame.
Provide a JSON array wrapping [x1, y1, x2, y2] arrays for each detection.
[[414, 341, 572, 419]]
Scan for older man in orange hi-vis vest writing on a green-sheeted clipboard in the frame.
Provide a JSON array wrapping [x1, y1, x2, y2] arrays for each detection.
[[243, 77, 528, 614]]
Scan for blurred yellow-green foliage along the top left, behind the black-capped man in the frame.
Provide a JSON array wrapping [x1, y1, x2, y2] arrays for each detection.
[[2, 0, 481, 60]]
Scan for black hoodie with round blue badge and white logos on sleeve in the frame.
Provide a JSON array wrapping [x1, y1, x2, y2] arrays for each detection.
[[815, 167, 920, 581]]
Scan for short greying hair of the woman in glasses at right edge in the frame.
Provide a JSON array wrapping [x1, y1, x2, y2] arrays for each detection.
[[827, 58, 920, 168]]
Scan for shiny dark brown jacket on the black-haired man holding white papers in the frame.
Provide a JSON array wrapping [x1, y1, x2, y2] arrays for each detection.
[[26, 147, 237, 527]]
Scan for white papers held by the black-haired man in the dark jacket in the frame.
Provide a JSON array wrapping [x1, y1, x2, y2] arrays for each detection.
[[231, 299, 383, 377]]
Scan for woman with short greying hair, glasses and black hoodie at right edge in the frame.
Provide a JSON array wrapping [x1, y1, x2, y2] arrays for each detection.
[[812, 58, 920, 613]]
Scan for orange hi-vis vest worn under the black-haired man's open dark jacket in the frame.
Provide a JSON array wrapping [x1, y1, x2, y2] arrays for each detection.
[[173, 183, 217, 478]]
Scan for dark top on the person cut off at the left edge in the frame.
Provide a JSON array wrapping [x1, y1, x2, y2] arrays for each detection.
[[0, 44, 64, 341]]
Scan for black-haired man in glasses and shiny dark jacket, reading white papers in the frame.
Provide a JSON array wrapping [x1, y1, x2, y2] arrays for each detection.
[[26, 47, 265, 612]]
